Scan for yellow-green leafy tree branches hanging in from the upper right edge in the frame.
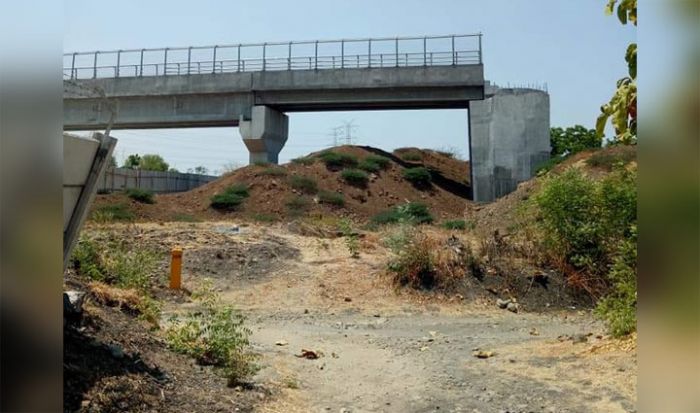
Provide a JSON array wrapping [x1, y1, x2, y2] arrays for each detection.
[[596, 0, 637, 144]]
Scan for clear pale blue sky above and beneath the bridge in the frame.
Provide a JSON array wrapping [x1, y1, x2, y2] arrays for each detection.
[[63, 0, 636, 172]]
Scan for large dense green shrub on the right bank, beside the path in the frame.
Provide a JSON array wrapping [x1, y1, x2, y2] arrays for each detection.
[[533, 168, 637, 334]]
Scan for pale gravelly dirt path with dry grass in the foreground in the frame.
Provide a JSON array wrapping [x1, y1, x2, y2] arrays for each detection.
[[135, 223, 637, 413]]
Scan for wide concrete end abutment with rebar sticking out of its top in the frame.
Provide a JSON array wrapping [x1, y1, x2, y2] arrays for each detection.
[[469, 87, 551, 202]]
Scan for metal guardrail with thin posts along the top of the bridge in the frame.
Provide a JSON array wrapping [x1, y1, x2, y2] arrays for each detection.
[[63, 33, 482, 79]]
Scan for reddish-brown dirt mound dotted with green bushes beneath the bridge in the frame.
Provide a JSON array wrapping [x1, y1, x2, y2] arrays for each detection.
[[94, 146, 470, 221]]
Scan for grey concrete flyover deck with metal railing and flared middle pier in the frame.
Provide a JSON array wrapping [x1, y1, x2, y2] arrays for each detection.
[[63, 34, 549, 200]]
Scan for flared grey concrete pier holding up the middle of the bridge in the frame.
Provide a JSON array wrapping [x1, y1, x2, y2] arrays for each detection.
[[238, 106, 289, 164]]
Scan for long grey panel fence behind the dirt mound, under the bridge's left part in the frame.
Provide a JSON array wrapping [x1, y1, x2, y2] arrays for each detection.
[[97, 168, 217, 193]]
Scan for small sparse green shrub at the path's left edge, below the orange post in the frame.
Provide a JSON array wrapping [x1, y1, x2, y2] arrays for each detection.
[[166, 293, 259, 386]]
